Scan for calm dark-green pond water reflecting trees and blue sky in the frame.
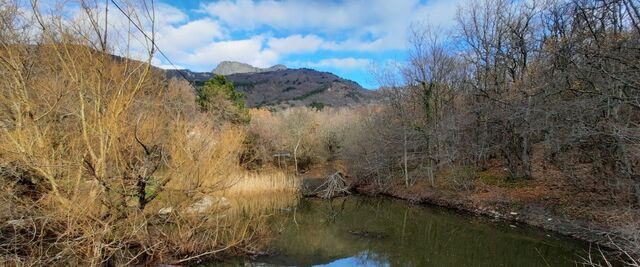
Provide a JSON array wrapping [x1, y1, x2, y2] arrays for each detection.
[[242, 197, 587, 267]]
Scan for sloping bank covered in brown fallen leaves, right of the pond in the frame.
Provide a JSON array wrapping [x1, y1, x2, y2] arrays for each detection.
[[303, 158, 640, 259]]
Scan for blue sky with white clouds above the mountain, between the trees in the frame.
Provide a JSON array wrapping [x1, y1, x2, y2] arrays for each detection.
[[149, 0, 464, 88]]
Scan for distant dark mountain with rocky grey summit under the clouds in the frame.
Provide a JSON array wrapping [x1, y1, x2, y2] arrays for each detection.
[[167, 62, 378, 109]]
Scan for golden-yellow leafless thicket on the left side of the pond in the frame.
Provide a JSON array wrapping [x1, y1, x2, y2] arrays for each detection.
[[0, 1, 264, 266]]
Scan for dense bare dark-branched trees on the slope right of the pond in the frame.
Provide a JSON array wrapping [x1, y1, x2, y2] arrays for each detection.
[[364, 0, 640, 201]]
